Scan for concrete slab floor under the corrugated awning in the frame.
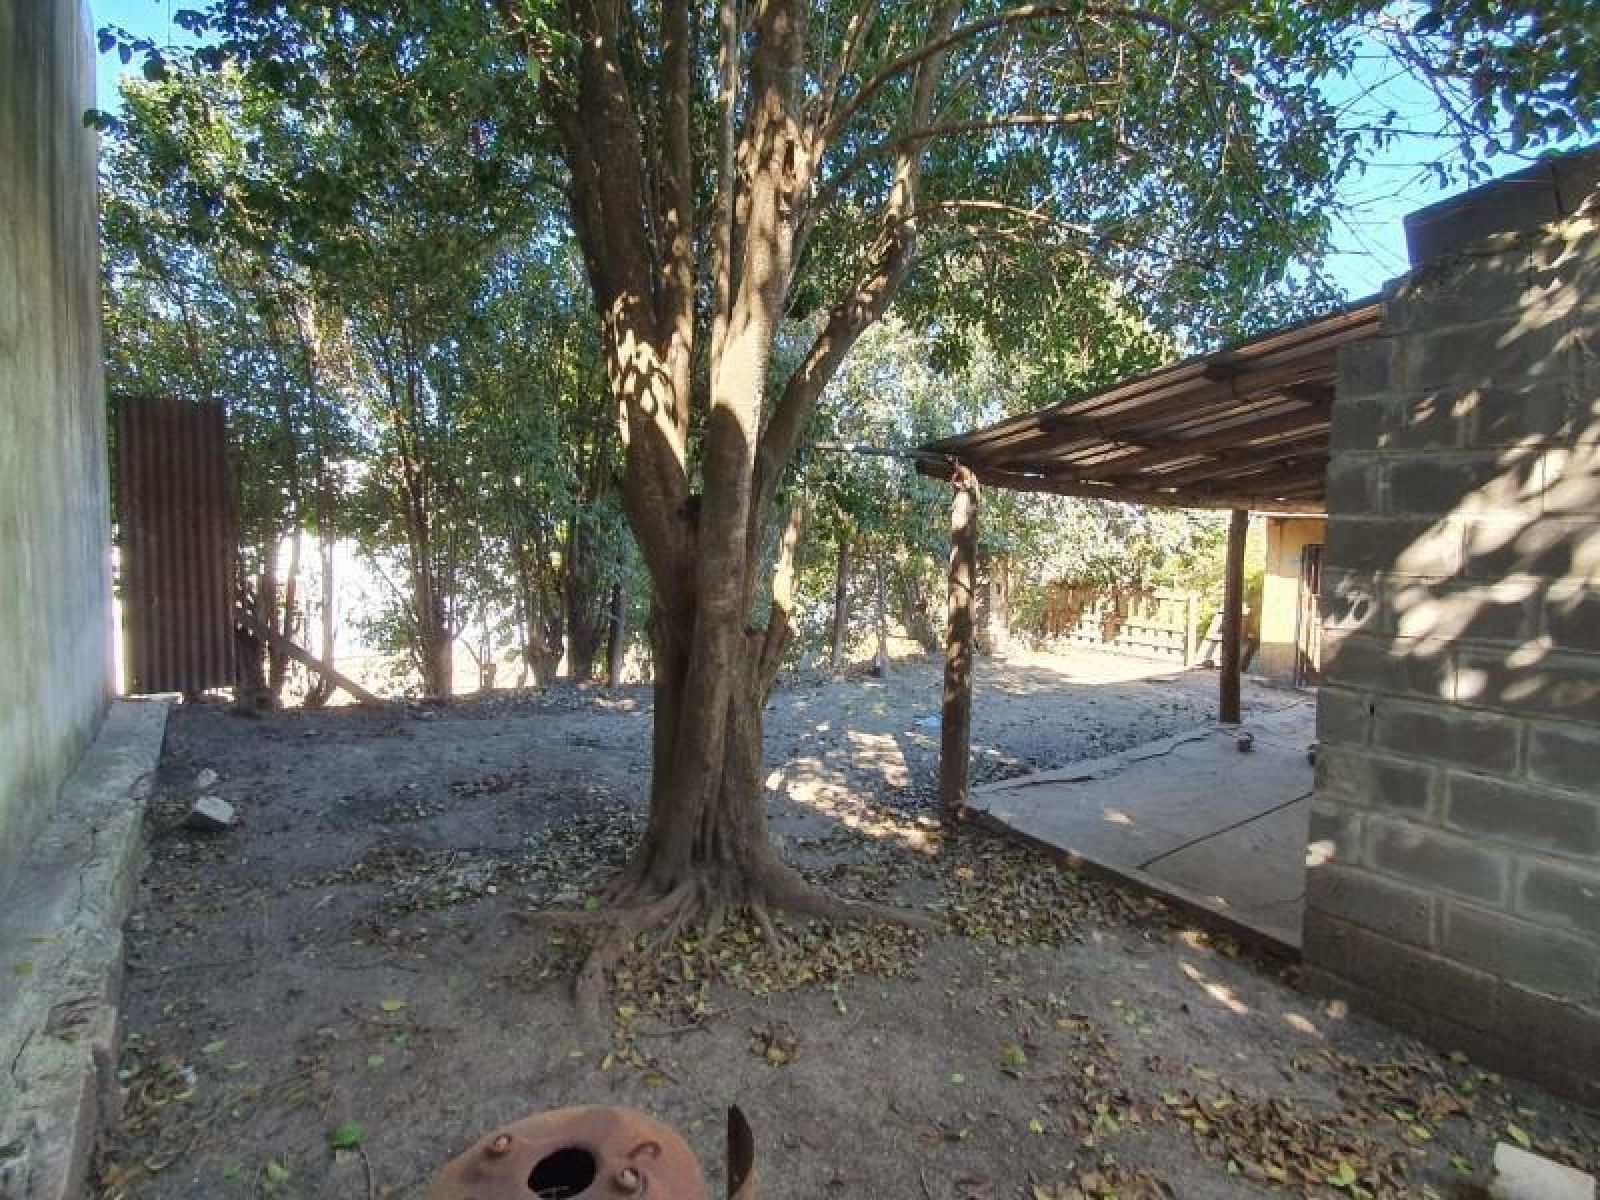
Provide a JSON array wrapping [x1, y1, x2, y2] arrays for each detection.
[[971, 698, 1317, 952]]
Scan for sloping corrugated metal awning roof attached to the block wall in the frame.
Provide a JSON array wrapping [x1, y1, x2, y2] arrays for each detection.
[[917, 296, 1384, 512]]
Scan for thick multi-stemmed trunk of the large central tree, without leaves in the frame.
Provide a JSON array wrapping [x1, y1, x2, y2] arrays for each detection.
[[501, 0, 958, 1017]]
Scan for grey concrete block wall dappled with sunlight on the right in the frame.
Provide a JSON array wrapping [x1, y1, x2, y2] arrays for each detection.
[[1304, 150, 1600, 1104]]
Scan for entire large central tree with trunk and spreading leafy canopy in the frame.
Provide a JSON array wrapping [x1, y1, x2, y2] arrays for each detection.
[[107, 0, 1600, 1017]]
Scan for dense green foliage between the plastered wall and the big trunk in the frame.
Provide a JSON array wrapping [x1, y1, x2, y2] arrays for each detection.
[[104, 44, 629, 691]]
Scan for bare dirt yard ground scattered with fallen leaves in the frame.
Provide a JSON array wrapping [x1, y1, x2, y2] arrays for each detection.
[[98, 653, 1600, 1200]]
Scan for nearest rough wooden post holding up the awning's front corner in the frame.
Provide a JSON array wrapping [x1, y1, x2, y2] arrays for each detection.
[[939, 467, 978, 818]]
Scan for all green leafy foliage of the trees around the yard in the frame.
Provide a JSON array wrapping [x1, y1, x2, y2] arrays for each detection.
[[88, 0, 1600, 694]]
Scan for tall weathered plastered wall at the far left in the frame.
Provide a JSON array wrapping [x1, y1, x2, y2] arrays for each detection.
[[0, 0, 110, 891]]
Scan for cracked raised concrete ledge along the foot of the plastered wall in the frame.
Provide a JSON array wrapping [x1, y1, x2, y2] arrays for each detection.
[[0, 701, 168, 1200]]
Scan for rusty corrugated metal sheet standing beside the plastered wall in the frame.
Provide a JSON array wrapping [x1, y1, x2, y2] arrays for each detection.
[[117, 398, 237, 694]]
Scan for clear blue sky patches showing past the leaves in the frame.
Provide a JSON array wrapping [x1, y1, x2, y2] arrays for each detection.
[[91, 0, 1580, 299]]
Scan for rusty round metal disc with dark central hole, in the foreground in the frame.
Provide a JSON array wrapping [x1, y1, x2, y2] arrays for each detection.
[[429, 1107, 707, 1200]]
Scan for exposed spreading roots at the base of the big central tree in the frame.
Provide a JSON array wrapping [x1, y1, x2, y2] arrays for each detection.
[[563, 862, 939, 1035]]
